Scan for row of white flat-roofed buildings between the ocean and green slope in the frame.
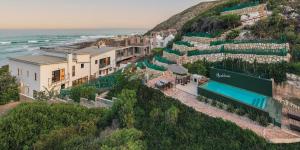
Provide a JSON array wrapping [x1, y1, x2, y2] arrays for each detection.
[[9, 46, 150, 98]]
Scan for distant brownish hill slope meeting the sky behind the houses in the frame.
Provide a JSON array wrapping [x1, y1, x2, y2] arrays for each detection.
[[147, 0, 226, 34]]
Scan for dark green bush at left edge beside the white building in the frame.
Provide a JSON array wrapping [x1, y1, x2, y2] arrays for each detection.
[[0, 66, 19, 105]]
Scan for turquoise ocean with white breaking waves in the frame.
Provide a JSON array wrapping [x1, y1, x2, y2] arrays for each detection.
[[0, 29, 147, 66]]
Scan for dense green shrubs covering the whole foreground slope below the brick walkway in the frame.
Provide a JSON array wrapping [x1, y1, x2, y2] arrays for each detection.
[[0, 77, 300, 150]]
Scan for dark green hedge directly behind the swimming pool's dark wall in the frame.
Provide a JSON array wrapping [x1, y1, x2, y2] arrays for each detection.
[[184, 58, 289, 83]]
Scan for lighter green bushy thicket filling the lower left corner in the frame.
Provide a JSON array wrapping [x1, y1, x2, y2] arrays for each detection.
[[0, 103, 106, 150]]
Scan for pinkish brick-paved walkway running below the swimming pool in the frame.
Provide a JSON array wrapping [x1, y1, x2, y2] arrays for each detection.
[[148, 76, 300, 143]]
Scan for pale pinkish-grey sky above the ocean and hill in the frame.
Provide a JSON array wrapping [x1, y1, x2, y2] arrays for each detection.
[[0, 0, 213, 29]]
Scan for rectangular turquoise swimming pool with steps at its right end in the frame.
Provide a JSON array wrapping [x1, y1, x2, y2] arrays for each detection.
[[201, 80, 268, 109]]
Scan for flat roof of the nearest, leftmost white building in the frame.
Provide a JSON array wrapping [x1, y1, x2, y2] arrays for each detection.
[[9, 55, 67, 65]]
